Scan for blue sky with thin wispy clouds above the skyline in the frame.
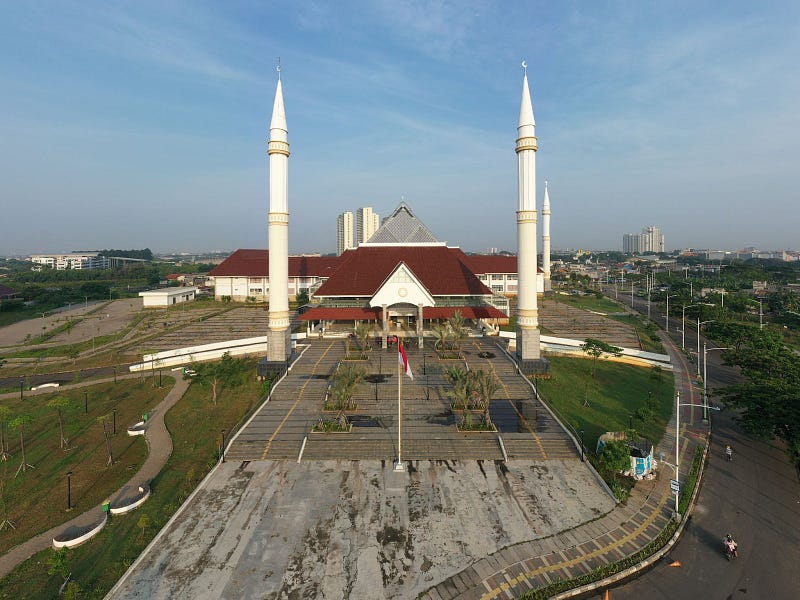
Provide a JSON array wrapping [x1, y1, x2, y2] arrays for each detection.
[[0, 0, 800, 255]]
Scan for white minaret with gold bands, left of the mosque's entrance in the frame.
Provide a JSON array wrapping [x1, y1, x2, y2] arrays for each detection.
[[267, 64, 292, 363]]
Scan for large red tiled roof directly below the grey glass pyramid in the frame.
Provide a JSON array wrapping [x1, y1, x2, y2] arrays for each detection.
[[314, 246, 492, 297]]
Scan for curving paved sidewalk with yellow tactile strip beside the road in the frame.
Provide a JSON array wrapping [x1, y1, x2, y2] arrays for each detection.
[[420, 334, 708, 600]]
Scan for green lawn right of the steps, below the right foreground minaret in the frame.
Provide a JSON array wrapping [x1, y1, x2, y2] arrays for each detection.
[[537, 356, 674, 453]]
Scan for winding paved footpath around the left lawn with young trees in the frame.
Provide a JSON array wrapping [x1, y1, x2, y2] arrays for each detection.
[[0, 375, 189, 577]]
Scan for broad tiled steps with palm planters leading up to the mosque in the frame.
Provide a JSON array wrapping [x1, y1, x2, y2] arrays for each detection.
[[228, 338, 579, 460]]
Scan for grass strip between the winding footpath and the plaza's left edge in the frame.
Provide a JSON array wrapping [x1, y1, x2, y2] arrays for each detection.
[[0, 360, 264, 600]]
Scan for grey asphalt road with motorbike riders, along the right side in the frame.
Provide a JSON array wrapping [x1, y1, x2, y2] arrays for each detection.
[[598, 291, 800, 600]]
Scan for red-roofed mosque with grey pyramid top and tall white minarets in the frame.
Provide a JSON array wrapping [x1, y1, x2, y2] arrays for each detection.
[[209, 63, 550, 373]]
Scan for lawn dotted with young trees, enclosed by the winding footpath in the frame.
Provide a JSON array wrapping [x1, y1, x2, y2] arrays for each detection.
[[0, 379, 173, 552]]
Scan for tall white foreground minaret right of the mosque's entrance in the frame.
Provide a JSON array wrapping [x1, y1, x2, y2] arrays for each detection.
[[516, 61, 541, 370]]
